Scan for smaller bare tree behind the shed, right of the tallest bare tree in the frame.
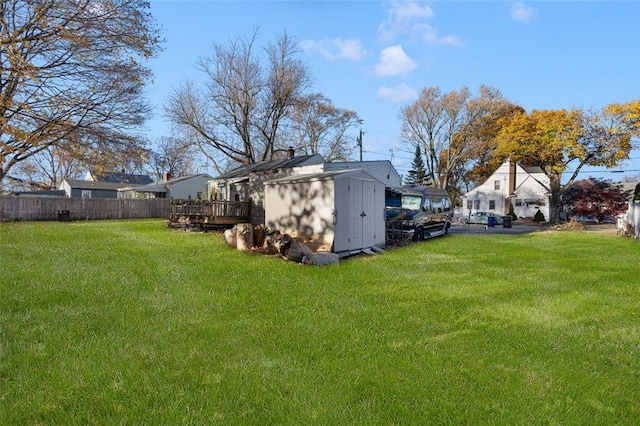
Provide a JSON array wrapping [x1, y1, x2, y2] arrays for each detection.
[[288, 93, 362, 161]]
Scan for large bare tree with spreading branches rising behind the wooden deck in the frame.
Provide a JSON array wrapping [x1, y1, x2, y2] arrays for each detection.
[[165, 31, 310, 171]]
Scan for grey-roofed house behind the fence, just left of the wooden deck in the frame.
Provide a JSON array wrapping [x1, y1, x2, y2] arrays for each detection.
[[118, 173, 212, 200]]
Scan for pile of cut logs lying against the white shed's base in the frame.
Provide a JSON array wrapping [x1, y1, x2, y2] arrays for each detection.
[[224, 223, 339, 265]]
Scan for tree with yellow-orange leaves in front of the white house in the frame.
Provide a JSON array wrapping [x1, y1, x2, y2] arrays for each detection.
[[496, 101, 640, 223]]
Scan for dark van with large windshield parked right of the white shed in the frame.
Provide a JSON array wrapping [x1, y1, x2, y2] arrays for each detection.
[[385, 185, 453, 241]]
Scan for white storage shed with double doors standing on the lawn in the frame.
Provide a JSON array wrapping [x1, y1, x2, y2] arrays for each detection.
[[265, 170, 385, 256]]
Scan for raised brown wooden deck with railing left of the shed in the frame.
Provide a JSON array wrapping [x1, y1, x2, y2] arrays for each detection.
[[169, 200, 250, 229]]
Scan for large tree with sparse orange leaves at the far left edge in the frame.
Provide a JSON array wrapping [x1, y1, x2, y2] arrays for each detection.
[[0, 0, 160, 187]]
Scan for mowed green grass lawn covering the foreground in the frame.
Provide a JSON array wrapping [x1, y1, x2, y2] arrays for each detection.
[[0, 220, 640, 425]]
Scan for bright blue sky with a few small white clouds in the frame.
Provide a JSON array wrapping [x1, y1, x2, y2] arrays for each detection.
[[148, 0, 640, 180]]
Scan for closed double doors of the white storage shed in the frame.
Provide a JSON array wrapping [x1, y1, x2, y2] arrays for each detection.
[[349, 178, 376, 250]]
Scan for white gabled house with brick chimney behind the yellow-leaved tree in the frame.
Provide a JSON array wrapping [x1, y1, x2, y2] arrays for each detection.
[[460, 160, 550, 220]]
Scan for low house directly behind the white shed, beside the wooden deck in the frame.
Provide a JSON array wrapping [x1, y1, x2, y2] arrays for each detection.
[[209, 150, 324, 225]]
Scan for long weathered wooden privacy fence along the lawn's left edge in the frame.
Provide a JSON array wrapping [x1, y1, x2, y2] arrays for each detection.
[[0, 196, 171, 221]]
